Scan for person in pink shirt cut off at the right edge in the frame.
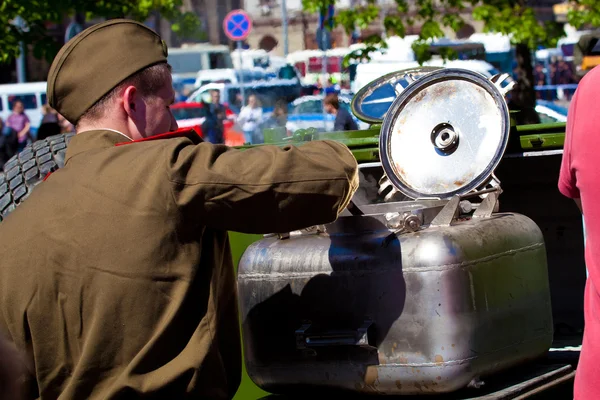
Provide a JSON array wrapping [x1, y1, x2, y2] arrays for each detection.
[[558, 67, 600, 400]]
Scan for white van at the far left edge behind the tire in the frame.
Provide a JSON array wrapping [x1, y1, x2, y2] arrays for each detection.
[[0, 82, 46, 136]]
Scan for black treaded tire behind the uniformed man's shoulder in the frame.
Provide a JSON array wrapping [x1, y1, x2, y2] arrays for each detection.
[[0, 133, 75, 221]]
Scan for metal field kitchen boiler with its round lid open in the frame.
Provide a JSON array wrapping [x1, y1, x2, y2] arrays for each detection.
[[238, 69, 553, 394]]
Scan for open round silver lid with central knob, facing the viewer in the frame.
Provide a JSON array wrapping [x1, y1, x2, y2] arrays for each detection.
[[379, 68, 510, 199]]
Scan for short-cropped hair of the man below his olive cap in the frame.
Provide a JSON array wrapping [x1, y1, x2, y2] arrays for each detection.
[[77, 63, 171, 125]]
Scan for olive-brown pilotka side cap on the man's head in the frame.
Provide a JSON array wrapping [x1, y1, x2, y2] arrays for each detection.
[[46, 19, 167, 124]]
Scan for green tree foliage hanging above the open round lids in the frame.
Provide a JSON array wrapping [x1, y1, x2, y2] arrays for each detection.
[[302, 0, 572, 63]]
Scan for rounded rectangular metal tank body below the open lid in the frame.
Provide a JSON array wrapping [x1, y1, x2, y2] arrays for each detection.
[[238, 208, 552, 394]]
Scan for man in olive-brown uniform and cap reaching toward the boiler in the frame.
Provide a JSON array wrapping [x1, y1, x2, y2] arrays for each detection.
[[0, 20, 358, 399]]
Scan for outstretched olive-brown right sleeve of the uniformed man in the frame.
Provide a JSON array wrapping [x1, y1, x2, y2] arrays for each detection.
[[167, 140, 358, 233]]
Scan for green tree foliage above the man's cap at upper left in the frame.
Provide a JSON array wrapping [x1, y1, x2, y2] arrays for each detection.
[[0, 0, 200, 62]]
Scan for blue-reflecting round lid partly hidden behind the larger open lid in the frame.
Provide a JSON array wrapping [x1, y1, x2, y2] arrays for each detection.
[[350, 67, 441, 124]]
